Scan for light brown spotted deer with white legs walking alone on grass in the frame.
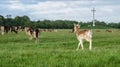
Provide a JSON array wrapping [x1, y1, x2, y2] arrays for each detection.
[[74, 24, 92, 50]]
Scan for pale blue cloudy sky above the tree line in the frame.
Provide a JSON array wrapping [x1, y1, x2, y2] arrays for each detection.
[[0, 0, 120, 22]]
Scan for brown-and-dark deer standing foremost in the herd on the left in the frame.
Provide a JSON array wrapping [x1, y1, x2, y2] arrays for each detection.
[[25, 27, 40, 43]]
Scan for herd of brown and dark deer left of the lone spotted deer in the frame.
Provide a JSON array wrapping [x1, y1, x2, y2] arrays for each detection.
[[0, 26, 57, 43]]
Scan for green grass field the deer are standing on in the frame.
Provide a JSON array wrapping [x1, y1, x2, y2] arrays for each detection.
[[0, 29, 120, 67]]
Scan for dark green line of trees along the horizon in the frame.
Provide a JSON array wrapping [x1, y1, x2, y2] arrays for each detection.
[[0, 15, 120, 29]]
